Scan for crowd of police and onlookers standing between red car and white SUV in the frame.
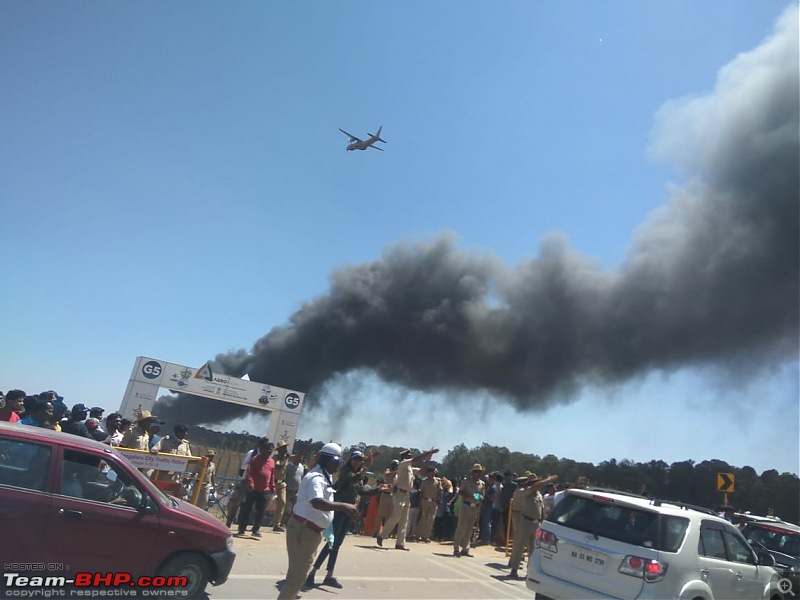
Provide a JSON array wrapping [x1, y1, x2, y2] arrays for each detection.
[[220, 438, 582, 598]]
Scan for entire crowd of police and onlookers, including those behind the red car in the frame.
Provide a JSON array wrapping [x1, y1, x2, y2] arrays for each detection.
[[0, 390, 580, 598]]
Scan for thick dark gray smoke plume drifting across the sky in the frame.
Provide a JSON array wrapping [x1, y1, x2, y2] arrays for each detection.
[[153, 6, 800, 422]]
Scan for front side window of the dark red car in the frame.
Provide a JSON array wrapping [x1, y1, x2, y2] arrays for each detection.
[[61, 450, 142, 506]]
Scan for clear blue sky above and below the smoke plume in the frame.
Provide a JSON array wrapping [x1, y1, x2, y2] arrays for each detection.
[[0, 0, 800, 473]]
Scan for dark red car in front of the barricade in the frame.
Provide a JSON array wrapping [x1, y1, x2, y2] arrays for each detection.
[[0, 422, 236, 598]]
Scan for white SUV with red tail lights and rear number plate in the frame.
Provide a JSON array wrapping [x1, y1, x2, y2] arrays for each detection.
[[526, 489, 783, 600]]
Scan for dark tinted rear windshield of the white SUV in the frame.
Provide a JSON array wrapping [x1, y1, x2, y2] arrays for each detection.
[[547, 494, 689, 552]]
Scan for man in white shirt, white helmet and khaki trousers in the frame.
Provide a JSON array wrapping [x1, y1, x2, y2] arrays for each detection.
[[278, 443, 358, 600]]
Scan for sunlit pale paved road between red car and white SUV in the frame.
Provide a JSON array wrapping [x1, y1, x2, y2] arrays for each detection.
[[208, 529, 534, 600]]
